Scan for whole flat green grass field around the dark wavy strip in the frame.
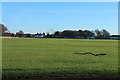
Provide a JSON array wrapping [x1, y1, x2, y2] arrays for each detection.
[[2, 38, 118, 78]]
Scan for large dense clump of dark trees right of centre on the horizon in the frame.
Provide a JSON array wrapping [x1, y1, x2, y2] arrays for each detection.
[[47, 29, 110, 39]]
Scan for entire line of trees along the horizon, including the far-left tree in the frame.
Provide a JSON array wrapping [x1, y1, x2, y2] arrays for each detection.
[[0, 24, 110, 39]]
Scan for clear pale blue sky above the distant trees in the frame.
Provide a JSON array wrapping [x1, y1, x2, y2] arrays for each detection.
[[2, 2, 118, 34]]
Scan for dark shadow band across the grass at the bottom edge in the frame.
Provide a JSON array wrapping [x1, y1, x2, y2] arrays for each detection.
[[2, 69, 118, 80]]
